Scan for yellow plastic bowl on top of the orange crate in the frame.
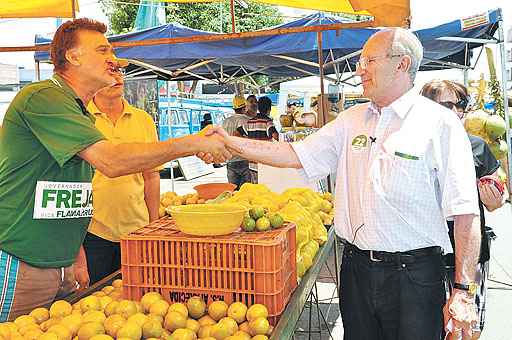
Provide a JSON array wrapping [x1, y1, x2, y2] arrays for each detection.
[[166, 204, 246, 236]]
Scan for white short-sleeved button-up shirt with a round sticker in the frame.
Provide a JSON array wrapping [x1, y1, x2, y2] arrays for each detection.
[[292, 91, 479, 252]]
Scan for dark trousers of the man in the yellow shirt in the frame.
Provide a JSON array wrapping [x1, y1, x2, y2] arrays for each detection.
[[84, 233, 121, 285]]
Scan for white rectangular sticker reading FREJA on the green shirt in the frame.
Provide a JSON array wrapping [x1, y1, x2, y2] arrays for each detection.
[[34, 181, 92, 219]]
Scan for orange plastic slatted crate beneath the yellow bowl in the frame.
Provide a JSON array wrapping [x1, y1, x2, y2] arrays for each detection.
[[121, 217, 297, 325]]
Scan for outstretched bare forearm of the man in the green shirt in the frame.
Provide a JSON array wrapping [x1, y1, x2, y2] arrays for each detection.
[[79, 136, 198, 177]]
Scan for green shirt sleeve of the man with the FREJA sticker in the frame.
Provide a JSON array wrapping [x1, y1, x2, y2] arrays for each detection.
[[21, 90, 105, 167]]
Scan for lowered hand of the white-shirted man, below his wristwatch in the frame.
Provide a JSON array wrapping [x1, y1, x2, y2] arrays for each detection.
[[443, 289, 478, 340]]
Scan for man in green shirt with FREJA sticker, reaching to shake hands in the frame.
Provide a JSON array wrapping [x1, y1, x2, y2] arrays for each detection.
[[0, 18, 231, 322]]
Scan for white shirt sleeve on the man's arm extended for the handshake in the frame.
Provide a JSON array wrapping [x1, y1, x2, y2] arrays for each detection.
[[291, 115, 344, 181]]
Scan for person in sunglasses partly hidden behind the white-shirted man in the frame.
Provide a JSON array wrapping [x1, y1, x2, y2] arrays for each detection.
[[420, 80, 505, 332]]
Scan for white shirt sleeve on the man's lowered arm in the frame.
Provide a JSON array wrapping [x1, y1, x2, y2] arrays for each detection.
[[438, 115, 480, 217]]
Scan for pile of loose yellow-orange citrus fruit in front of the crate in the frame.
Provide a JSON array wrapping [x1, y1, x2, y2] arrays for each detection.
[[0, 280, 272, 340]]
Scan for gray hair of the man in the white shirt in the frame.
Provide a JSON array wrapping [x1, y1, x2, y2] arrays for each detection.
[[384, 27, 423, 82]]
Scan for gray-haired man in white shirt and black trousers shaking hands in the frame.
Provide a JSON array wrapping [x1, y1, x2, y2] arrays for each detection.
[[202, 28, 480, 340]]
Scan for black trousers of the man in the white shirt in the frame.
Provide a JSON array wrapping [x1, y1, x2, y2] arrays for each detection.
[[340, 245, 446, 340]]
